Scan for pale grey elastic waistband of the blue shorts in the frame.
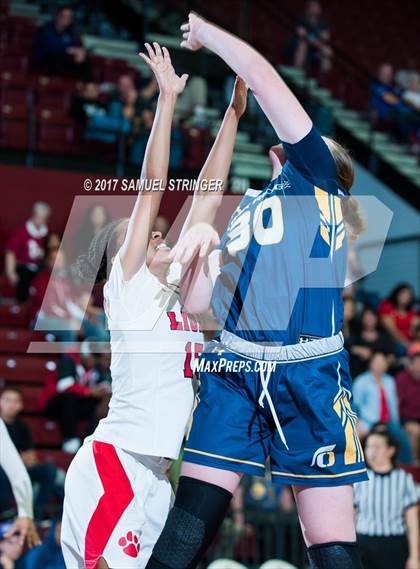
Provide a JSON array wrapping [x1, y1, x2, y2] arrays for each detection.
[[220, 330, 344, 362]]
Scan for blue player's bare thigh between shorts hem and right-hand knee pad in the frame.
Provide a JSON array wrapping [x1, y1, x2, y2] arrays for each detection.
[[293, 485, 356, 547]]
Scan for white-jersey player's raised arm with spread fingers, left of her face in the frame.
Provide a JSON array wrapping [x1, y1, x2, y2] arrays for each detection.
[[120, 42, 188, 280]]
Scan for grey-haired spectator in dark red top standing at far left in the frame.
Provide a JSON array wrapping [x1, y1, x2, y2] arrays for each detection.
[[5, 202, 51, 302]]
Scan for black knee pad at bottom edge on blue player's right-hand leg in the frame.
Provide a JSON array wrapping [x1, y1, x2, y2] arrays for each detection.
[[308, 541, 363, 569]]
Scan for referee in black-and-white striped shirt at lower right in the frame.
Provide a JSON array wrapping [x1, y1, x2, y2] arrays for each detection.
[[354, 431, 419, 569]]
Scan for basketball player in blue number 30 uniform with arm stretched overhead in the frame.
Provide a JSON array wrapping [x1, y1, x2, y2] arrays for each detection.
[[147, 14, 367, 569]]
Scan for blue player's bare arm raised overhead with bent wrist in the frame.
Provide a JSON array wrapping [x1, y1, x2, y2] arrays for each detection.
[[181, 13, 312, 144]]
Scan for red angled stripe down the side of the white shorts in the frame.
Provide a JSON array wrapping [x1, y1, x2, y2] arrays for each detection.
[[85, 441, 134, 569]]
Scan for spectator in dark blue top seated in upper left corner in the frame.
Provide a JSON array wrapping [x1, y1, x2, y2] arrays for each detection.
[[33, 6, 90, 81]]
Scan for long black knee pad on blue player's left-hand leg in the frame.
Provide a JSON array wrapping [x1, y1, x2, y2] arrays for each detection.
[[146, 476, 232, 569]]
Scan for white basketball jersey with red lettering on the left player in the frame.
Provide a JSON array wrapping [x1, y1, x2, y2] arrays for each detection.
[[92, 253, 204, 459]]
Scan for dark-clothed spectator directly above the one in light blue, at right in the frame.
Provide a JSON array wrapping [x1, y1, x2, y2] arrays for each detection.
[[347, 306, 395, 377]]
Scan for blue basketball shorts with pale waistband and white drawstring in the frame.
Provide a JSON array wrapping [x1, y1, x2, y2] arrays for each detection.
[[184, 332, 368, 486]]
